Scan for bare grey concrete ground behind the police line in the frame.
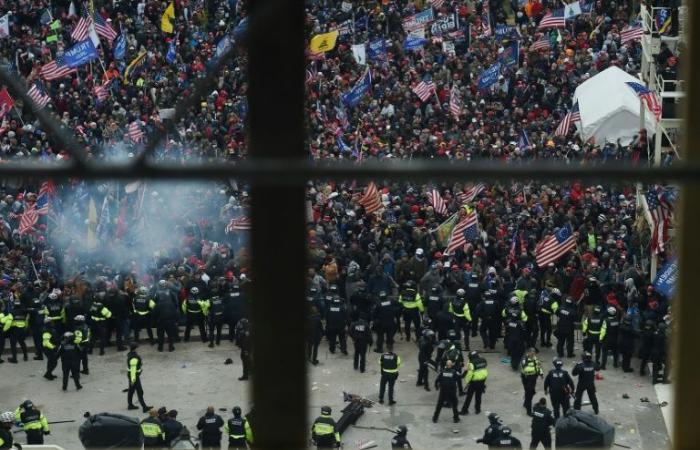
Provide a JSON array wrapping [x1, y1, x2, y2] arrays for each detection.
[[0, 332, 669, 450]]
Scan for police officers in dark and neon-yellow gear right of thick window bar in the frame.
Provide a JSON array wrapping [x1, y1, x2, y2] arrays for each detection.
[[307, 276, 670, 448]]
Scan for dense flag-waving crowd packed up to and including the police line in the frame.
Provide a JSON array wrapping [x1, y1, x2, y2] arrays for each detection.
[[0, 0, 682, 446]]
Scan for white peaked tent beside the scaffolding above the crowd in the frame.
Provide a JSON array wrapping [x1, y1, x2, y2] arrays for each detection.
[[574, 67, 656, 145]]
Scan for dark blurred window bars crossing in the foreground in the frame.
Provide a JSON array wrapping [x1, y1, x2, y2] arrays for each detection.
[[0, 0, 700, 449]]
